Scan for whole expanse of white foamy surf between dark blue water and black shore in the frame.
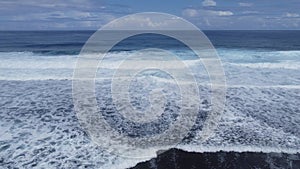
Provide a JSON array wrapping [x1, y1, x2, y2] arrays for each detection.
[[0, 50, 300, 168]]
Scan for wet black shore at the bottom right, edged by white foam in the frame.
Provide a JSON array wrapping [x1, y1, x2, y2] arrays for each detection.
[[133, 149, 300, 169]]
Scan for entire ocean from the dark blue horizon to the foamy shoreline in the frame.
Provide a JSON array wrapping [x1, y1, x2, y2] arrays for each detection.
[[0, 31, 300, 168]]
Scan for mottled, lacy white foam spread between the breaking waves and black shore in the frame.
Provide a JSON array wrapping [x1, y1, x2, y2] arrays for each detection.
[[0, 80, 300, 168]]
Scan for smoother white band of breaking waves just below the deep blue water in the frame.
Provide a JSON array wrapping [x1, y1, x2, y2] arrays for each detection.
[[0, 49, 300, 85]]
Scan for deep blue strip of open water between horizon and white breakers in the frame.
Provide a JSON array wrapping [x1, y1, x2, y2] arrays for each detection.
[[0, 31, 300, 55]]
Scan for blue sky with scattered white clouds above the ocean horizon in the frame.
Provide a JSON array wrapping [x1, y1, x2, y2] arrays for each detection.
[[0, 0, 300, 30]]
